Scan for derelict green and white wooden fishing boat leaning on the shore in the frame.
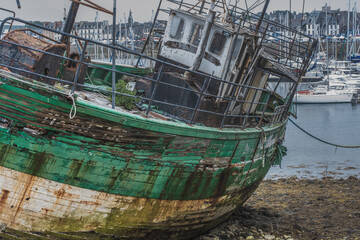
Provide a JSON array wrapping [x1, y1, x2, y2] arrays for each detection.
[[0, 0, 316, 239]]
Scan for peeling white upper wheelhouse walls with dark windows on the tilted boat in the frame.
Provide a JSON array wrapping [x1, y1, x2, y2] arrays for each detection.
[[159, 10, 244, 78]]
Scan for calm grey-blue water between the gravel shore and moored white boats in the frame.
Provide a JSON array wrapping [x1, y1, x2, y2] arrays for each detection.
[[267, 104, 360, 178]]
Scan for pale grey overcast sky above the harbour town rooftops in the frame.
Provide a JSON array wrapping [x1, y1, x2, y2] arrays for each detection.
[[0, 0, 355, 22]]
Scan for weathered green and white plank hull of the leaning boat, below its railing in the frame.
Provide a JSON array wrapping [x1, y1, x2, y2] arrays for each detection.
[[0, 71, 286, 238]]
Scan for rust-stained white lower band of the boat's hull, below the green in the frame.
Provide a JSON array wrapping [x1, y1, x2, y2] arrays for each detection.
[[0, 167, 259, 238]]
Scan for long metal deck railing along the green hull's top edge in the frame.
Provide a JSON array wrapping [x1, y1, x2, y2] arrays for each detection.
[[0, 17, 314, 128]]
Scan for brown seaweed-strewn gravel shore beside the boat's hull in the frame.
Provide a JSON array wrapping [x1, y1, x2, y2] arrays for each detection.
[[196, 177, 360, 240]]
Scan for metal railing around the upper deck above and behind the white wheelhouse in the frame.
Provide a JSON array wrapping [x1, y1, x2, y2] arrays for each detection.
[[167, 0, 315, 77]]
